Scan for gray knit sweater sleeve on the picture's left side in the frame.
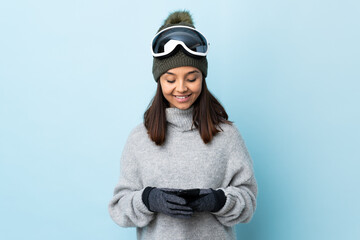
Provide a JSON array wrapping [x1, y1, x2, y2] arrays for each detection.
[[108, 127, 154, 227]]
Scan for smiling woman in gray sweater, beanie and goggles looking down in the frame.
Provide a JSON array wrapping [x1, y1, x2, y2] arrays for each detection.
[[109, 11, 257, 239]]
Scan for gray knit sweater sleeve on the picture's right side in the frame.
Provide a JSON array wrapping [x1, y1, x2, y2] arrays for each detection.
[[213, 127, 257, 227]]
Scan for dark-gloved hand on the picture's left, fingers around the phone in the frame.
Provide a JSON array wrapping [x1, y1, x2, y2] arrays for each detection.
[[142, 187, 194, 218]]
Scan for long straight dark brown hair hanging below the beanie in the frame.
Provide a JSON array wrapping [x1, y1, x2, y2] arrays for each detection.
[[144, 78, 232, 146]]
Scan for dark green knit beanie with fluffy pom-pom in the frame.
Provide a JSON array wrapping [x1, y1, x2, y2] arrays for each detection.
[[152, 11, 208, 82]]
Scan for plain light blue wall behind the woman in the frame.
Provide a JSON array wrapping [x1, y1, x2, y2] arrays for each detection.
[[0, 0, 360, 240]]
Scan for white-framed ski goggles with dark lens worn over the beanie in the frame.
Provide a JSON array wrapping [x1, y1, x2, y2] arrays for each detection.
[[151, 26, 210, 57]]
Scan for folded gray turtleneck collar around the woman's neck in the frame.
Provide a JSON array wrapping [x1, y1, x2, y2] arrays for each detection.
[[165, 106, 195, 132]]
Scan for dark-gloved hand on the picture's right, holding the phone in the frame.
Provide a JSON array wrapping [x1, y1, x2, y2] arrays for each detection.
[[187, 188, 226, 212]]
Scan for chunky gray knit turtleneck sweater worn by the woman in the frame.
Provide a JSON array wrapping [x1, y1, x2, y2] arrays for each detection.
[[109, 107, 257, 240]]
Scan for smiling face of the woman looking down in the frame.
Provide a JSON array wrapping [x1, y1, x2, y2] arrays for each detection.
[[160, 66, 202, 109]]
